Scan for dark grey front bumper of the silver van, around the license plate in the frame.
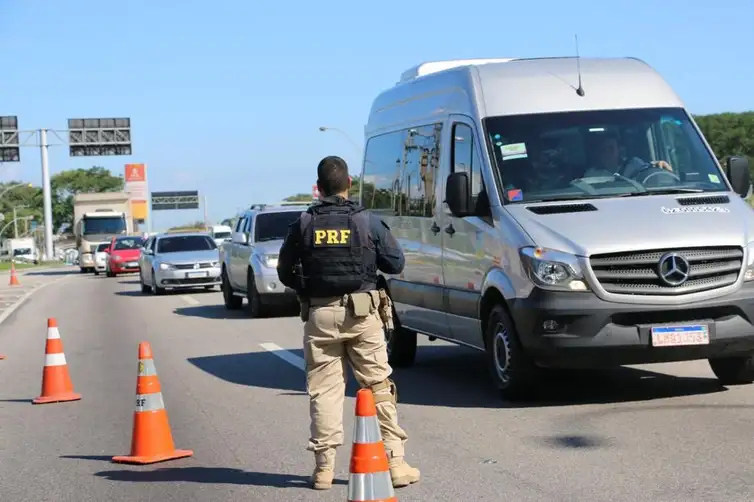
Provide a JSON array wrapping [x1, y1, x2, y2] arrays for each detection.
[[511, 284, 754, 368]]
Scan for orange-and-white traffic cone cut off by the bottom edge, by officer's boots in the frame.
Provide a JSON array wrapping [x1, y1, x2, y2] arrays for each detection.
[[348, 389, 398, 502]]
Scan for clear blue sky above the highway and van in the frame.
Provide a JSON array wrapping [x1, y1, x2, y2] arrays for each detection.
[[0, 0, 754, 229]]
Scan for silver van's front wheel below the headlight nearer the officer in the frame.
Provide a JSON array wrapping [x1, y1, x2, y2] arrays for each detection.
[[485, 305, 540, 401]]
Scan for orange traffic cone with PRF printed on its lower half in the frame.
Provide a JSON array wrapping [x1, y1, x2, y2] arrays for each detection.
[[113, 342, 194, 464]]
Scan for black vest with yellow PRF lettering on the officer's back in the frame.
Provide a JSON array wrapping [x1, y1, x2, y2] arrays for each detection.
[[301, 201, 377, 298]]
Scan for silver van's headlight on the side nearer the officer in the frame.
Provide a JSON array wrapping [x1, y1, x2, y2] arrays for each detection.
[[521, 247, 589, 291]]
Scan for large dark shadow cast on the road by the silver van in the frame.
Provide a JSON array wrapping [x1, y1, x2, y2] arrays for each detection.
[[188, 346, 726, 410]]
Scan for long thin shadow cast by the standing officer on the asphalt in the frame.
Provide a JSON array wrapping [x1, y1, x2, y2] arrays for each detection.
[[94, 467, 348, 488]]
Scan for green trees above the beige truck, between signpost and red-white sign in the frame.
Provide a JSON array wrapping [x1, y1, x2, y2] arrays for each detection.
[[50, 166, 124, 229]]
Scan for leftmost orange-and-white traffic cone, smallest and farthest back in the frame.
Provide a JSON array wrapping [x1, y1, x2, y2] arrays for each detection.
[[32, 317, 81, 404]]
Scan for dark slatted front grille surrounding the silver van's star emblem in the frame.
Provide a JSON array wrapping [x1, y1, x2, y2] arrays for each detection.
[[589, 247, 744, 295]]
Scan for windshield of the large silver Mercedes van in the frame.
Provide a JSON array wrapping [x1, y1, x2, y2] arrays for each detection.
[[484, 108, 728, 203]]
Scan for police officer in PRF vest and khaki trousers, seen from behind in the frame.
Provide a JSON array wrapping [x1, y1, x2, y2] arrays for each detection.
[[277, 156, 420, 490]]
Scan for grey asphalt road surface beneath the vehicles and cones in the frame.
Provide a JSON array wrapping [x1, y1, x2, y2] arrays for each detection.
[[0, 272, 754, 502]]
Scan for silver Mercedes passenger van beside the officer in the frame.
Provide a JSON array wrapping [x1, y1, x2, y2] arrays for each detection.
[[360, 58, 754, 399]]
